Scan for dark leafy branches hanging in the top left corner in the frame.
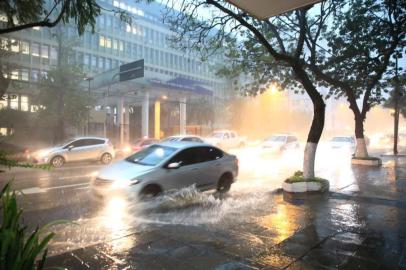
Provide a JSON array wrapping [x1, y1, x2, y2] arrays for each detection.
[[0, 0, 131, 35]]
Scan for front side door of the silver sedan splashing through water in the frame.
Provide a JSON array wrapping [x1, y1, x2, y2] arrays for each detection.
[[165, 148, 201, 189]]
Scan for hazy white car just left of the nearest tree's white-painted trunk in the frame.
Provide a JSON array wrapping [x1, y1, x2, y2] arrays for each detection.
[[261, 134, 300, 154]]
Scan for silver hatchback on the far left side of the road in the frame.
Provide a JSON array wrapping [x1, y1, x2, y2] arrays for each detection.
[[33, 137, 115, 167]]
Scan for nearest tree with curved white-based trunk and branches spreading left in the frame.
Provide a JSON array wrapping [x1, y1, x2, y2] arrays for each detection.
[[161, 0, 338, 178]]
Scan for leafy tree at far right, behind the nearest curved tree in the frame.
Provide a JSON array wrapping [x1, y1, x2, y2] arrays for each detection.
[[306, 0, 406, 158]]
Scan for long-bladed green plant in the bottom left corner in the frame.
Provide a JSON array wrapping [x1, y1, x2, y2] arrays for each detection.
[[0, 183, 55, 270]]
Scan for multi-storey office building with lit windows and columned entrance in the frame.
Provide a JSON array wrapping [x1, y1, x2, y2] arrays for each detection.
[[0, 0, 230, 146]]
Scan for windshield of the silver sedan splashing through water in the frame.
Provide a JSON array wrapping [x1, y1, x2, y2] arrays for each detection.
[[125, 145, 176, 166]]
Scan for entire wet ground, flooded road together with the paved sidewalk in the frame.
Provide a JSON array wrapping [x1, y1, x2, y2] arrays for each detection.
[[0, 147, 406, 269]]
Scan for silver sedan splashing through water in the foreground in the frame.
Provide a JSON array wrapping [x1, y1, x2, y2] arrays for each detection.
[[91, 141, 238, 197]]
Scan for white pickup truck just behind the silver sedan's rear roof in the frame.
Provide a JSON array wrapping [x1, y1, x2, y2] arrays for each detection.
[[205, 130, 246, 149]]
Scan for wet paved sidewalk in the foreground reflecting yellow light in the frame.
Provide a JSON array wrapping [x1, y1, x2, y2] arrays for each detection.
[[44, 158, 406, 270]]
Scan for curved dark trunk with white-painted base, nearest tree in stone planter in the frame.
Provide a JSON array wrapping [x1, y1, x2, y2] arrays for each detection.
[[293, 65, 326, 179]]
